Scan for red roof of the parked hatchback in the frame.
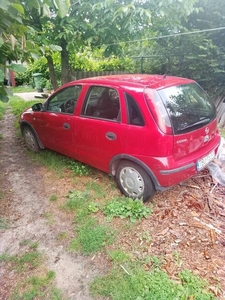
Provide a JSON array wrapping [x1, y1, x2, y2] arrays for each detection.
[[73, 74, 194, 89]]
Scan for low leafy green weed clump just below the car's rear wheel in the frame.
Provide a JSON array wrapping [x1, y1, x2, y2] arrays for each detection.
[[103, 198, 151, 222]]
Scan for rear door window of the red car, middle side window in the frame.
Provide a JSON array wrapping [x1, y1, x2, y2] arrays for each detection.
[[82, 86, 120, 120]]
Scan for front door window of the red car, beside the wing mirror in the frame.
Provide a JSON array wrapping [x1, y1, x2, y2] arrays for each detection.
[[46, 85, 81, 114]]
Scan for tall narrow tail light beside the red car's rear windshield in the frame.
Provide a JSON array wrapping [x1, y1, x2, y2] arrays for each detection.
[[144, 88, 173, 135]]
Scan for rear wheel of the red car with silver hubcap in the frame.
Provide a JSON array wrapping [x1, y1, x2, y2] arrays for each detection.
[[116, 160, 155, 201]]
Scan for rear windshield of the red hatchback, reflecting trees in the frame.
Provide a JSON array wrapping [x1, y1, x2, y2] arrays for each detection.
[[158, 83, 216, 134]]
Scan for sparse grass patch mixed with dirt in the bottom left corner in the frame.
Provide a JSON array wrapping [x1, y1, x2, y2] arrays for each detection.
[[0, 240, 63, 300]]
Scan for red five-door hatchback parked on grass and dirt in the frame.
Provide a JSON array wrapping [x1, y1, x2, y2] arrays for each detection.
[[19, 74, 220, 201]]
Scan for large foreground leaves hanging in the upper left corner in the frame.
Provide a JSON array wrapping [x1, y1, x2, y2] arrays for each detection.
[[0, 0, 70, 101]]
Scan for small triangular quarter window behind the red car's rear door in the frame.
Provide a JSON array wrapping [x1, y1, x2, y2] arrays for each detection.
[[125, 93, 145, 126]]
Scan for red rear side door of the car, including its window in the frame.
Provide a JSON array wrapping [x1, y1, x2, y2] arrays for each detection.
[[75, 85, 126, 172]]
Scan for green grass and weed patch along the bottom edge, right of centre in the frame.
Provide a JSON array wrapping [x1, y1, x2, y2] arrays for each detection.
[[91, 263, 215, 300]]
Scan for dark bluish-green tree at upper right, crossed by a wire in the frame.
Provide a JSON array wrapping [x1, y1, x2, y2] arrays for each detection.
[[127, 0, 225, 98]]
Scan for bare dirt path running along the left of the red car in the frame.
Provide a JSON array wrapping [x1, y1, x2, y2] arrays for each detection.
[[0, 112, 104, 300]]
